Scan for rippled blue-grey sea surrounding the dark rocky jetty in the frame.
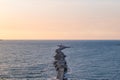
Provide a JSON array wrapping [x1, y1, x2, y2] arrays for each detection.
[[0, 40, 120, 80]]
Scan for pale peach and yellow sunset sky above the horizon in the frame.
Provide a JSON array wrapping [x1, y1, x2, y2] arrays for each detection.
[[0, 0, 120, 40]]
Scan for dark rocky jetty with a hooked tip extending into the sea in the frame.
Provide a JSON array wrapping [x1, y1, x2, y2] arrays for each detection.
[[53, 45, 70, 80]]
